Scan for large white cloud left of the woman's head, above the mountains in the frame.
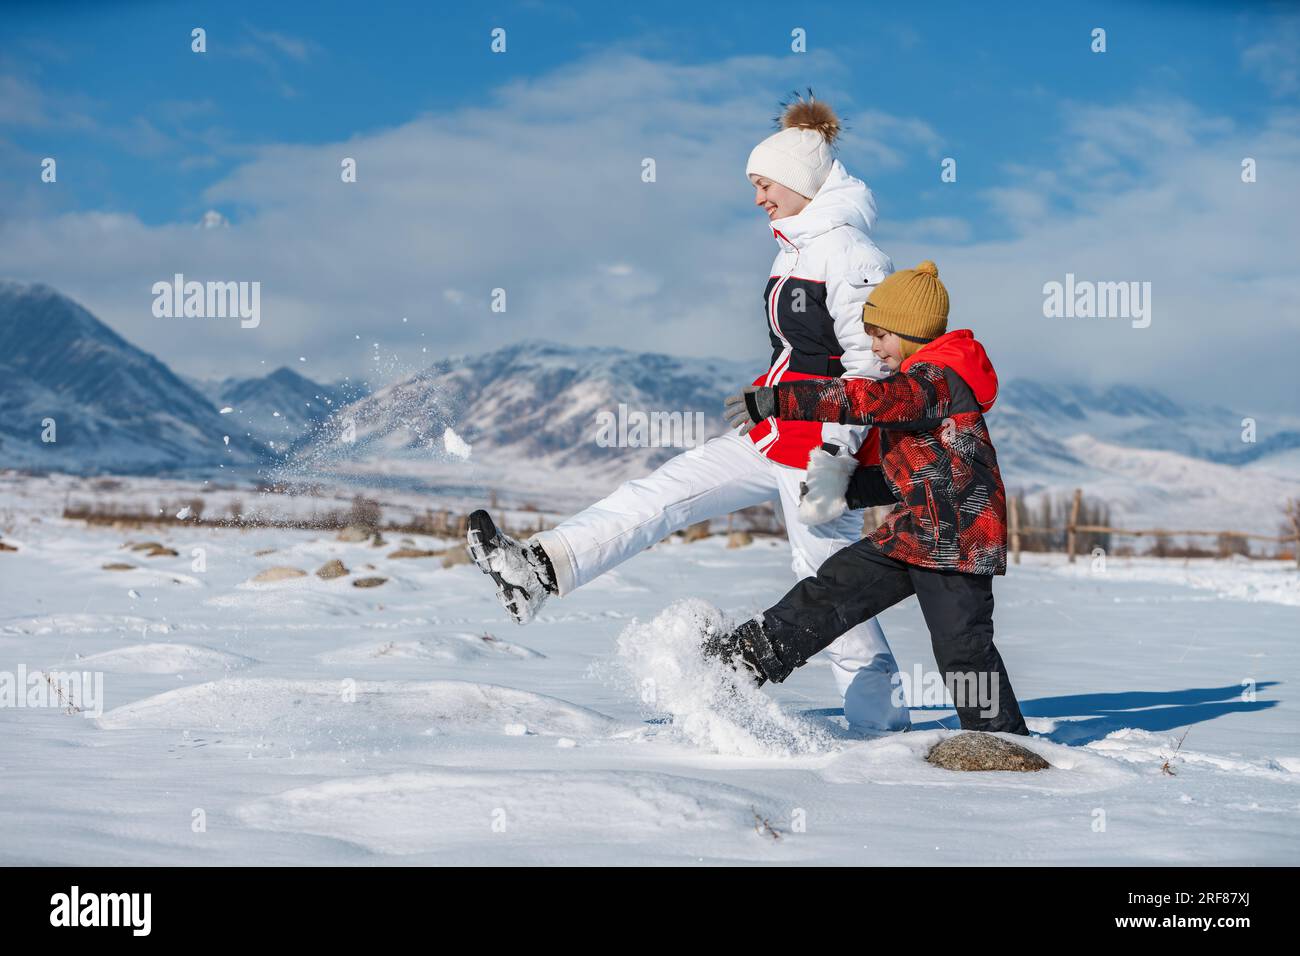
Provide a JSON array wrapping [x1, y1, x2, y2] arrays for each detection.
[[0, 53, 937, 385]]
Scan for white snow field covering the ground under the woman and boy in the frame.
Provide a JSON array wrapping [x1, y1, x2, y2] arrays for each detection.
[[0, 486, 1300, 865]]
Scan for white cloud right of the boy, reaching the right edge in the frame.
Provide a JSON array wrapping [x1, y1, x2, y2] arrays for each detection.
[[888, 101, 1300, 411]]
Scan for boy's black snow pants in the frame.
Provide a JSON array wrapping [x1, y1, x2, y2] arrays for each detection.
[[763, 538, 1030, 735]]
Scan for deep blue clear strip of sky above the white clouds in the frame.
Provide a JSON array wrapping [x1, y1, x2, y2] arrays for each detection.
[[4, 1, 1289, 222]]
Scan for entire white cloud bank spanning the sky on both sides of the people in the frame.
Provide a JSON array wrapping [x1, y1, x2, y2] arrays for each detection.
[[0, 53, 1300, 421]]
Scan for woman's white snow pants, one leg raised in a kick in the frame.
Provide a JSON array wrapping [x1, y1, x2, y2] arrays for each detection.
[[533, 432, 910, 730]]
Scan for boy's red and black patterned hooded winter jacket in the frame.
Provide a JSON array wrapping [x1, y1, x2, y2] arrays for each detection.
[[776, 329, 1006, 575]]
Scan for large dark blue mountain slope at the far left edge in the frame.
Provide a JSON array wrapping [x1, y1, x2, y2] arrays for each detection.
[[0, 281, 255, 472]]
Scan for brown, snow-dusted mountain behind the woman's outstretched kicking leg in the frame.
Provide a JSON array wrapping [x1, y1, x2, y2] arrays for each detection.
[[284, 342, 753, 486]]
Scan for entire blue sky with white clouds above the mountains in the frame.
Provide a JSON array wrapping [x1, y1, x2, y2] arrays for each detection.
[[0, 3, 1300, 401]]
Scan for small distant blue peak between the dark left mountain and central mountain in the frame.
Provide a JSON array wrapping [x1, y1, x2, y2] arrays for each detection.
[[190, 365, 368, 447]]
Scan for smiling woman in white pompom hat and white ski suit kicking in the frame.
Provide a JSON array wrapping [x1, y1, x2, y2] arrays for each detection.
[[469, 95, 909, 731]]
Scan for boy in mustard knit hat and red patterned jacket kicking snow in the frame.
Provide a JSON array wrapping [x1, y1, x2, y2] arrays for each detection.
[[705, 261, 1028, 735]]
